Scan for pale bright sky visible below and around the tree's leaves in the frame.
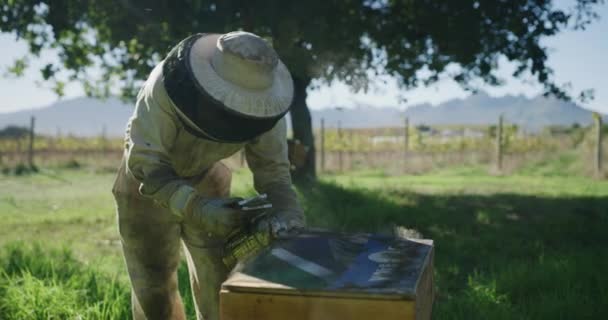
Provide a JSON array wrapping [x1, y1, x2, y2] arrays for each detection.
[[0, 0, 608, 114]]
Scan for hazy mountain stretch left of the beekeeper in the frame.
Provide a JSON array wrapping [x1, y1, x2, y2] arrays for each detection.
[[0, 97, 133, 137]]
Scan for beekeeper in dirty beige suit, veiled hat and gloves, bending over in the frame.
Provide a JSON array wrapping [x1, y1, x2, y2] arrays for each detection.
[[113, 32, 304, 320]]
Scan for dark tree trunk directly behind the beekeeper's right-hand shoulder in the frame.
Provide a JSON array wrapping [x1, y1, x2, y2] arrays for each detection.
[[291, 77, 316, 185]]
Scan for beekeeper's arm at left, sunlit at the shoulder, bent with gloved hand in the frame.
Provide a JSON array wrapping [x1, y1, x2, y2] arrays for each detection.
[[127, 68, 243, 235]]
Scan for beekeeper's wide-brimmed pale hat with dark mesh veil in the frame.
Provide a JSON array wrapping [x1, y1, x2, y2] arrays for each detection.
[[163, 31, 294, 143]]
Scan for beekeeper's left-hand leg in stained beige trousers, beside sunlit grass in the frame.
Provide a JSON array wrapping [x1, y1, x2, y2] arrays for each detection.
[[114, 164, 186, 320]]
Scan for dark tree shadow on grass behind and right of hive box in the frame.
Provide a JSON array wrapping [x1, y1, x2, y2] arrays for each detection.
[[304, 183, 608, 319]]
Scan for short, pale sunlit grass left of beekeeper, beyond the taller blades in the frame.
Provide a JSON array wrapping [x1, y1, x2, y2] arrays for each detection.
[[0, 170, 122, 278]]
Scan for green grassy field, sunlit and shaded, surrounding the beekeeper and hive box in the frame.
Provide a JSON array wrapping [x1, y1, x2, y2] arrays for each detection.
[[0, 156, 608, 319]]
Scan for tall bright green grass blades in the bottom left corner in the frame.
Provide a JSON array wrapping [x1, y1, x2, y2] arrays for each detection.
[[0, 244, 130, 319]]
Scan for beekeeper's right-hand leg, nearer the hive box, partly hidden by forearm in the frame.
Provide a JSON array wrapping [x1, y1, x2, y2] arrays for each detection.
[[182, 162, 232, 320]]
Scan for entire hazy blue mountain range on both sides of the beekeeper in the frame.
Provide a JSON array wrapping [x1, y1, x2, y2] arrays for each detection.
[[0, 93, 608, 136]]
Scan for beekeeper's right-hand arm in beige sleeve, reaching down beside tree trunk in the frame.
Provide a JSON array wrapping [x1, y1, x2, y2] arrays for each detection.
[[245, 118, 305, 229]]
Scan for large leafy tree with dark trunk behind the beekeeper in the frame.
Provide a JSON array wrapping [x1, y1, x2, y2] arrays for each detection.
[[0, 0, 603, 181]]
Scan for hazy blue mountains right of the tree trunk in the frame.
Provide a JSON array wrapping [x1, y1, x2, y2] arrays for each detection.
[[313, 93, 604, 130]]
